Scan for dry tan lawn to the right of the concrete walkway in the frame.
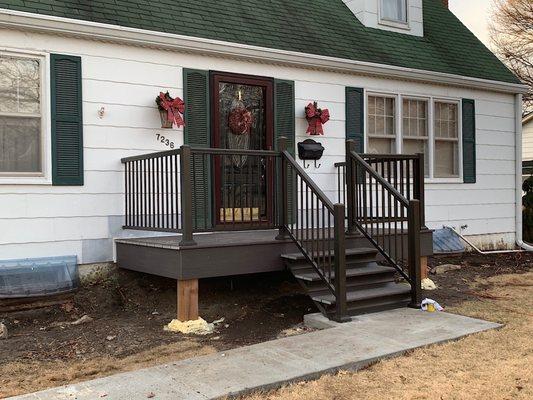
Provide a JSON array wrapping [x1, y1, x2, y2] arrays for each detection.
[[246, 272, 533, 400]]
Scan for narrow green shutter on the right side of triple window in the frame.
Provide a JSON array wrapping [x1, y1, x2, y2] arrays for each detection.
[[462, 99, 476, 183]]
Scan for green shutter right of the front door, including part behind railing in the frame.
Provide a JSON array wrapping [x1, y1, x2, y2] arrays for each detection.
[[274, 79, 297, 222]]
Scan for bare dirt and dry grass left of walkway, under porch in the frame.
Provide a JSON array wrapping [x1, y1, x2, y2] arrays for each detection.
[[0, 271, 315, 398]]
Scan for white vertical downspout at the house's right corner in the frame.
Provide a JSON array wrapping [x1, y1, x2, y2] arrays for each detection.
[[515, 94, 533, 251]]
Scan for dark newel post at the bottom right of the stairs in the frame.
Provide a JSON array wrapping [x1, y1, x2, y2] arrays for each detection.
[[407, 199, 422, 308]]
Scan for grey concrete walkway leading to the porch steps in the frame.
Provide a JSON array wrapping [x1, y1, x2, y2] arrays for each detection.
[[11, 308, 500, 400]]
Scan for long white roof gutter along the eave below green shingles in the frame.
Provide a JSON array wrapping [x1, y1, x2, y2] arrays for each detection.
[[0, 9, 527, 94]]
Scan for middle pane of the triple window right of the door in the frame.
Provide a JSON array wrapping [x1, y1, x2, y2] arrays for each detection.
[[402, 98, 429, 176]]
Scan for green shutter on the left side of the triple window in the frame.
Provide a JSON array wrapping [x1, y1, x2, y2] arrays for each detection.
[[346, 87, 365, 153]]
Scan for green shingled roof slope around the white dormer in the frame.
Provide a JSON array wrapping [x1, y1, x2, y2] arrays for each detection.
[[0, 0, 520, 83]]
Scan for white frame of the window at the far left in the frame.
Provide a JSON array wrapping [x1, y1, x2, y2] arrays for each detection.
[[0, 47, 52, 185]]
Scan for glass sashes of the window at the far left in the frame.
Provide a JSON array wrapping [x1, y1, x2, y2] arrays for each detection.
[[0, 54, 43, 176]]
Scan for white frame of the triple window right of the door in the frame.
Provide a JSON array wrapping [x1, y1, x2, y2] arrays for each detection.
[[364, 89, 463, 183]]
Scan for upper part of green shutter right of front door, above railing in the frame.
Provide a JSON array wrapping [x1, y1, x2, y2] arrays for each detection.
[[274, 79, 296, 156]]
